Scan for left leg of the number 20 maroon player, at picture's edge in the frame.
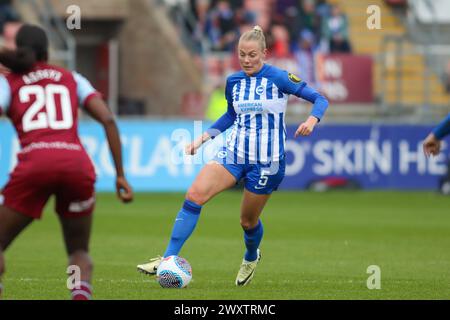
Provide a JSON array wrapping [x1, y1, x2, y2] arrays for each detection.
[[0, 205, 33, 298]]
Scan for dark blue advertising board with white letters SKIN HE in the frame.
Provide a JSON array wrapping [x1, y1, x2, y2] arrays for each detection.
[[282, 125, 450, 190]]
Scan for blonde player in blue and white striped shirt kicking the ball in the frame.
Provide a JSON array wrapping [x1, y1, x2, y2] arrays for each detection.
[[137, 26, 328, 286]]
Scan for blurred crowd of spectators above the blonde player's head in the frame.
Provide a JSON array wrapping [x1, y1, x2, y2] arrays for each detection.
[[174, 0, 351, 57]]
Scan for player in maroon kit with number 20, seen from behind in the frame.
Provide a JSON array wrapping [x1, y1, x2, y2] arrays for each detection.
[[0, 25, 133, 300]]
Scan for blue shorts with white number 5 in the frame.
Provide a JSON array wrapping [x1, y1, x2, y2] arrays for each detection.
[[212, 148, 286, 194]]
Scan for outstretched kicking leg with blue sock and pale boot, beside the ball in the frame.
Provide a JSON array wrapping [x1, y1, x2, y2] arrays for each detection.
[[137, 161, 237, 274]]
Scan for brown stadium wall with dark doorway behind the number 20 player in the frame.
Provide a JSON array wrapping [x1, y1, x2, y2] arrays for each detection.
[[4, 0, 202, 116]]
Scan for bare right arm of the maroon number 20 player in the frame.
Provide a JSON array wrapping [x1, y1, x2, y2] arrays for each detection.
[[85, 97, 133, 203]]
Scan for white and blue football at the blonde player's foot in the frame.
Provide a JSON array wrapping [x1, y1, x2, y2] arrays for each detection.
[[156, 256, 192, 288]]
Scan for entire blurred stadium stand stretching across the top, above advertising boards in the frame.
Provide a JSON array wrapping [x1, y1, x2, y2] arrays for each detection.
[[4, 0, 450, 119]]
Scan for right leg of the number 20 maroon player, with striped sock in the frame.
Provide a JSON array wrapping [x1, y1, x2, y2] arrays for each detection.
[[60, 215, 93, 300]]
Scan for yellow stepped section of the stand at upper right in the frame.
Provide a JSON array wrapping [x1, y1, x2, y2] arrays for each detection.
[[330, 0, 450, 110]]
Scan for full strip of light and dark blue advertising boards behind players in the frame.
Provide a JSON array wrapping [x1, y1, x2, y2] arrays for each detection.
[[0, 120, 450, 191]]
